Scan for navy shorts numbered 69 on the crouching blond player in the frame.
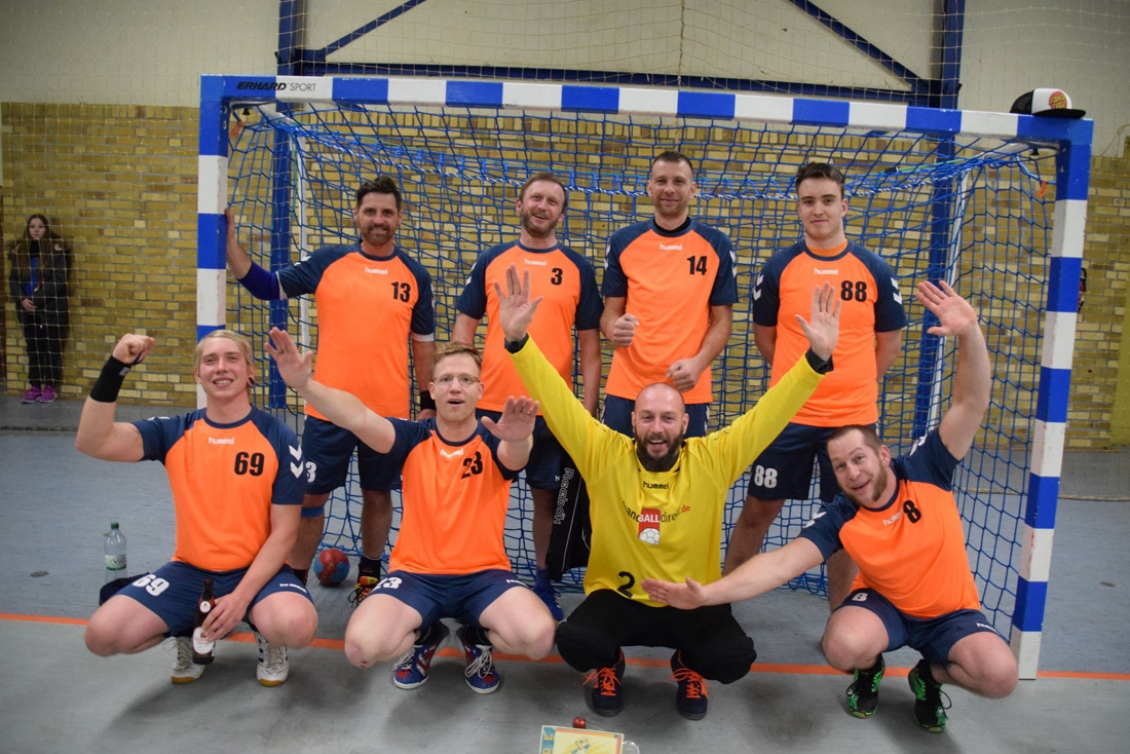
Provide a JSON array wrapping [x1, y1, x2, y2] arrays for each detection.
[[118, 561, 314, 635]]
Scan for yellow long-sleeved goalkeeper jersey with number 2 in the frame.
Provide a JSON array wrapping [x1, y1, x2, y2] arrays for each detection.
[[511, 338, 820, 606]]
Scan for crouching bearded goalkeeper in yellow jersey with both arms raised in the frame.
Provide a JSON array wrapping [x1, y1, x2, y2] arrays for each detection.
[[496, 266, 840, 720]]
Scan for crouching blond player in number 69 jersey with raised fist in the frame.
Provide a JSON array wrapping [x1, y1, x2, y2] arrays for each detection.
[[75, 330, 318, 686]]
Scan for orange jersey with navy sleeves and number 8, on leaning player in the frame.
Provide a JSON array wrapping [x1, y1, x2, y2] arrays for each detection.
[[800, 429, 981, 618]]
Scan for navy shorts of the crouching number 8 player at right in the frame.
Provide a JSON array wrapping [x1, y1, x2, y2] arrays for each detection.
[[836, 589, 1005, 664]]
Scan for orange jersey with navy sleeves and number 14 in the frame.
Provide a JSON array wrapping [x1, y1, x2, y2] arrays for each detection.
[[601, 219, 738, 404]]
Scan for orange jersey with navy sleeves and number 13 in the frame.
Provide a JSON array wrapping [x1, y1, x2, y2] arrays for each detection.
[[277, 244, 435, 419]]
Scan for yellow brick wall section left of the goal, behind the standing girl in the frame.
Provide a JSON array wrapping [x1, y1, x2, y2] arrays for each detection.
[[2, 103, 198, 406]]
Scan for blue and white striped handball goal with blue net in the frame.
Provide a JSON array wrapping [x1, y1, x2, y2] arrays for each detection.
[[197, 76, 1093, 678]]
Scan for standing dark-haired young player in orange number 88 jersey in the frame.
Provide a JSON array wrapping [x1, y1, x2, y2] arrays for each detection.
[[725, 163, 906, 609]]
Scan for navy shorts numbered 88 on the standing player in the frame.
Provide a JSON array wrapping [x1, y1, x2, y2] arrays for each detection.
[[747, 423, 840, 503]]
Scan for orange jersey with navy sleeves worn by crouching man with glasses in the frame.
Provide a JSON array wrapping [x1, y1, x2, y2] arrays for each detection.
[[379, 418, 522, 575]]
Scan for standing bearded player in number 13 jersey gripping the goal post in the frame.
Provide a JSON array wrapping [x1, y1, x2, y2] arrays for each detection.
[[227, 175, 435, 604]]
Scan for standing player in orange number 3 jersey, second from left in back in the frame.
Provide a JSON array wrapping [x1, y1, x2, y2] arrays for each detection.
[[451, 173, 601, 621]]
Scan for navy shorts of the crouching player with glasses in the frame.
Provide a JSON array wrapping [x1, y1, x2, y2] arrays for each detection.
[[370, 569, 527, 627]]
